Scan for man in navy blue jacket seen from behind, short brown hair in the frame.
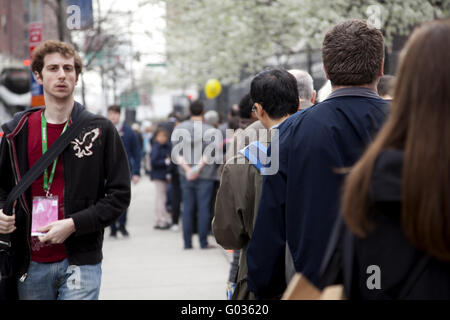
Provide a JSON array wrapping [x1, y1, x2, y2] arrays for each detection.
[[247, 20, 388, 299]]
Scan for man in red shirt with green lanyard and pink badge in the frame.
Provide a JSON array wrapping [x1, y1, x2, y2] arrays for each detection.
[[0, 40, 130, 300]]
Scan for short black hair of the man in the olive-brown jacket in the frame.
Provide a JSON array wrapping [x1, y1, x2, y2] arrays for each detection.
[[250, 69, 299, 119]]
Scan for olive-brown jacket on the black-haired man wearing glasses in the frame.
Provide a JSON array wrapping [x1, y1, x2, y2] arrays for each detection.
[[212, 121, 270, 300]]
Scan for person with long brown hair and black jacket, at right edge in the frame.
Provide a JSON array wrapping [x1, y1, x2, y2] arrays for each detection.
[[342, 19, 450, 299]]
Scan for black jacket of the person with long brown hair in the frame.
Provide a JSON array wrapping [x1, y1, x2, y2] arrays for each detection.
[[346, 150, 450, 300]]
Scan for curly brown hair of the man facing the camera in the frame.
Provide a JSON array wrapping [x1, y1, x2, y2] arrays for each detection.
[[31, 40, 82, 77]]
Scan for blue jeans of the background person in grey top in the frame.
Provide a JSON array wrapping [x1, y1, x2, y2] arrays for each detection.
[[180, 176, 214, 248]]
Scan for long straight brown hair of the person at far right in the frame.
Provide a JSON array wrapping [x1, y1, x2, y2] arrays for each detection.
[[342, 19, 450, 261]]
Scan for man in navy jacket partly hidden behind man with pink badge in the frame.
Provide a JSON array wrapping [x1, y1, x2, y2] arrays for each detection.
[[107, 105, 141, 237]]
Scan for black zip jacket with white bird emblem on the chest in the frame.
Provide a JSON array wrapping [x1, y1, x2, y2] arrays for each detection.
[[0, 102, 131, 276]]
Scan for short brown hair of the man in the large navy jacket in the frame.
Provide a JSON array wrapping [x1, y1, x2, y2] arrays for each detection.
[[322, 20, 384, 86]]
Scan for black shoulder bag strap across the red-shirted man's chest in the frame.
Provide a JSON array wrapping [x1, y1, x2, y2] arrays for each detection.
[[0, 111, 92, 250]]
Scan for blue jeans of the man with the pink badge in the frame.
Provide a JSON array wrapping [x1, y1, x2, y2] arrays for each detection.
[[18, 259, 102, 300]]
